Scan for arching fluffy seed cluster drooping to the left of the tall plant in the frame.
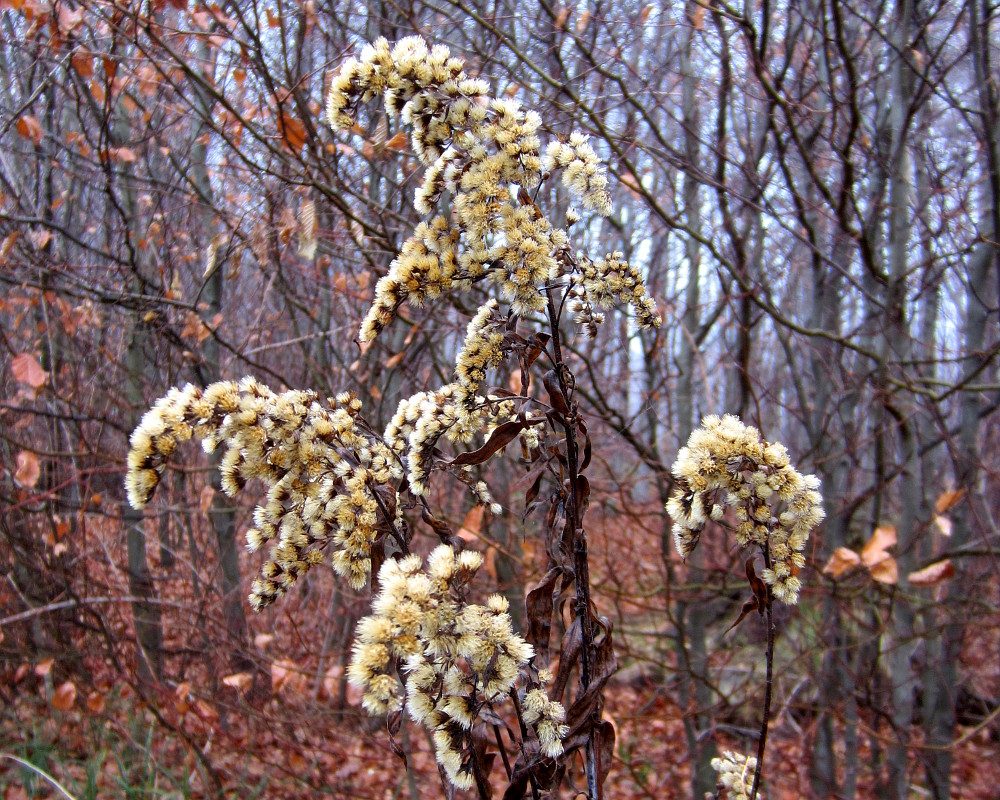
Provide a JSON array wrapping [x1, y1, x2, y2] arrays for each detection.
[[125, 378, 403, 610]]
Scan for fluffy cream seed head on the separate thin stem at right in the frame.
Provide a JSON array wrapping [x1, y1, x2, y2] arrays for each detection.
[[667, 414, 824, 603]]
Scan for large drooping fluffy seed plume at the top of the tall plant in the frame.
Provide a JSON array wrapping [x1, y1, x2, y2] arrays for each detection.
[[327, 37, 621, 341]]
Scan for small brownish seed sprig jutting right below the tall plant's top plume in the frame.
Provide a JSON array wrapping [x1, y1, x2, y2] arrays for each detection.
[[569, 251, 660, 338]]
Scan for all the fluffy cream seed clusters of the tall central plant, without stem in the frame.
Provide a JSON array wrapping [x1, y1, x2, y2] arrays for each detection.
[[126, 37, 659, 788]]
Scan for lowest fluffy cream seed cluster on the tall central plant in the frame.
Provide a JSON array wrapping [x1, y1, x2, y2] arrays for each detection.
[[349, 545, 566, 789]]
